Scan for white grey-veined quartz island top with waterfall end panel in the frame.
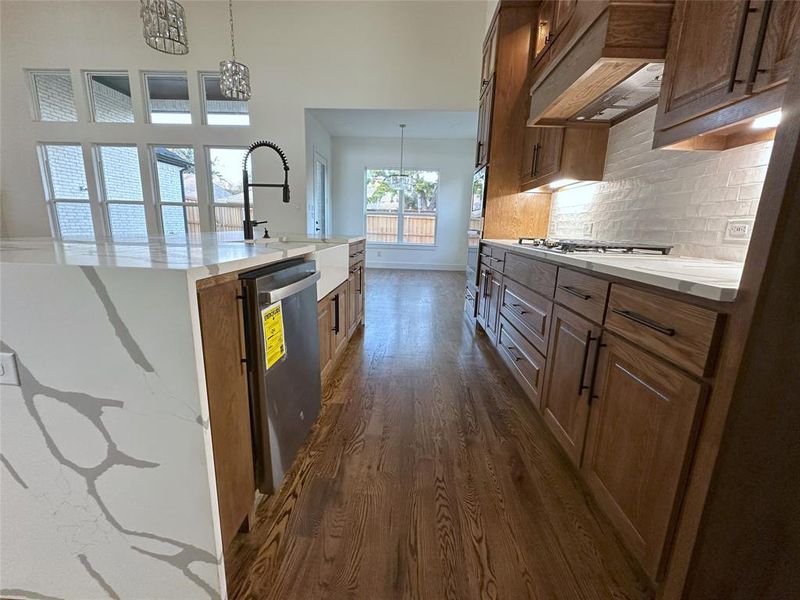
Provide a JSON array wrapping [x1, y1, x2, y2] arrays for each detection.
[[0, 234, 360, 598]]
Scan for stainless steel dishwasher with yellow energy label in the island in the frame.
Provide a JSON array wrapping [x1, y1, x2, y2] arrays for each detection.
[[239, 259, 321, 494]]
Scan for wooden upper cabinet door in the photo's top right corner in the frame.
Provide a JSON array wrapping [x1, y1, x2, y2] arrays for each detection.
[[753, 0, 800, 92]]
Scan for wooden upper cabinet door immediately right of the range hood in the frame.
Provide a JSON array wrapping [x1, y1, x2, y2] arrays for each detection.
[[656, 0, 760, 129]]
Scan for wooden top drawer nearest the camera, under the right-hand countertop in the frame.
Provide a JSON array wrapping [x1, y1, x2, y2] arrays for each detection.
[[605, 284, 720, 377]]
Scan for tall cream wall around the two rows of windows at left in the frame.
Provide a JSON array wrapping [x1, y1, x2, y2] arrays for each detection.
[[0, 0, 486, 236]]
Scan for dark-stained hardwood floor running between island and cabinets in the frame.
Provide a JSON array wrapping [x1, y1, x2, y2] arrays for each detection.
[[226, 270, 652, 600]]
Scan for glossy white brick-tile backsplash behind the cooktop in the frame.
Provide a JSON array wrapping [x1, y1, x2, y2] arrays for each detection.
[[549, 107, 772, 261]]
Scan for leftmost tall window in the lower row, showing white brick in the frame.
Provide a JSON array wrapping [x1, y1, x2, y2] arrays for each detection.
[[39, 144, 94, 239]]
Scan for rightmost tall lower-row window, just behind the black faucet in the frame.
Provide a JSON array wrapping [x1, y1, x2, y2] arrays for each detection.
[[208, 148, 253, 237]]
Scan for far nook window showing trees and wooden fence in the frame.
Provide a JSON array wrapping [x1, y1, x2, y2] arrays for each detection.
[[364, 169, 439, 245]]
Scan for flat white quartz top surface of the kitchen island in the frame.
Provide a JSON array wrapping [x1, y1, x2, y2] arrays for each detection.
[[0, 233, 318, 278]]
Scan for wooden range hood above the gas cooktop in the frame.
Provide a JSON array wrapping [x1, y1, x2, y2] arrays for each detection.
[[527, 0, 674, 126]]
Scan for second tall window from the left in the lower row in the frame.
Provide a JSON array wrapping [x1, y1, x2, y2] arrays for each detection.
[[95, 146, 147, 239]]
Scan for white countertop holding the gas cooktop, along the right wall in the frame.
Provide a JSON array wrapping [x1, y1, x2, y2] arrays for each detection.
[[483, 240, 744, 302]]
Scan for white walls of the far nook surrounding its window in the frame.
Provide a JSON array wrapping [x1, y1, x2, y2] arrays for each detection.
[[333, 137, 475, 270]]
